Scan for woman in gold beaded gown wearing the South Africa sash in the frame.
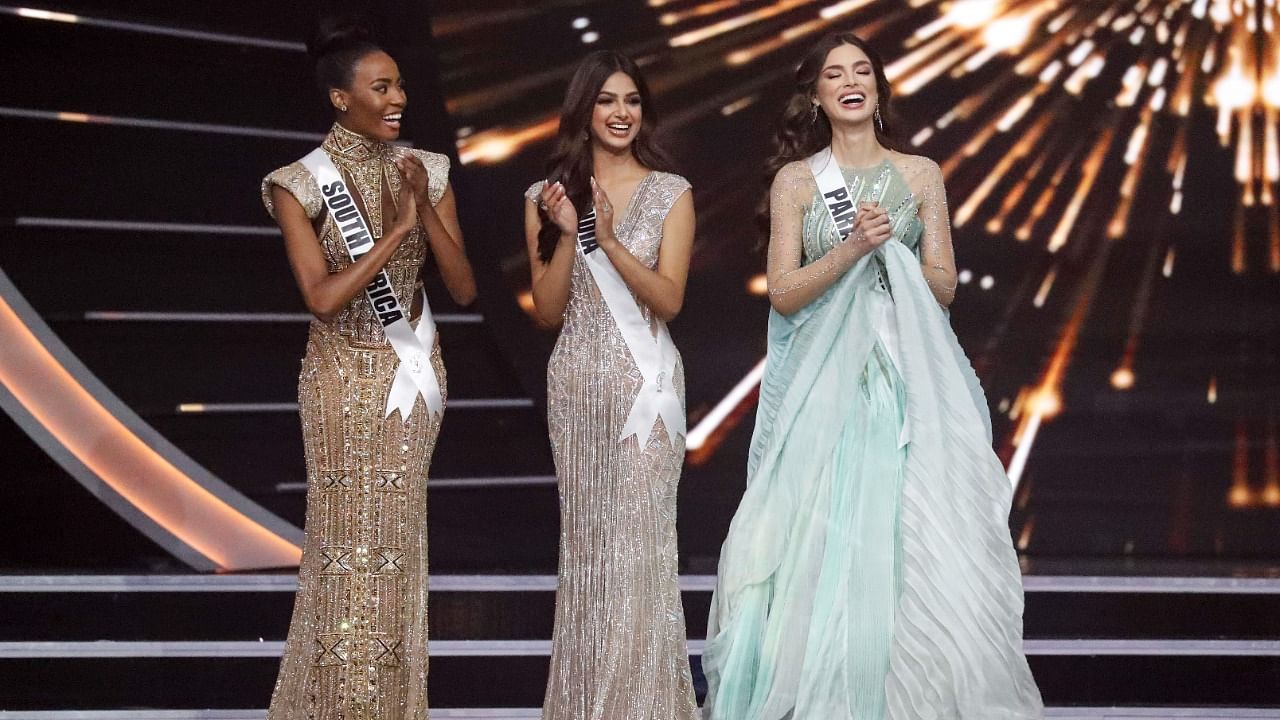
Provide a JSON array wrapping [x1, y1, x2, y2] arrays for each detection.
[[262, 18, 475, 720]]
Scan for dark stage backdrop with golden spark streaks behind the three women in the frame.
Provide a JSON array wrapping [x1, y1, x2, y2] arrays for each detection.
[[0, 0, 1280, 573]]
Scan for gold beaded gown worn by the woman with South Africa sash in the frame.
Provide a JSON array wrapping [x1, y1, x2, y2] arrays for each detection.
[[262, 124, 449, 720]]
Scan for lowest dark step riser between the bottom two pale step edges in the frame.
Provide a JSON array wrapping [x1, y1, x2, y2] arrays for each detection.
[[0, 641, 1280, 710]]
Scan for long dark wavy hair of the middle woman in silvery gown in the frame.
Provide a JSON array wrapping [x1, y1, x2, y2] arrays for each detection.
[[538, 50, 671, 263]]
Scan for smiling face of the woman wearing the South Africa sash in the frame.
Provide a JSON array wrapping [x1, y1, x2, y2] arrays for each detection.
[[329, 51, 408, 142]]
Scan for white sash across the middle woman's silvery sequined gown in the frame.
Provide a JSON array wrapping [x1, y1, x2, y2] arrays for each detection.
[[577, 209, 686, 447]]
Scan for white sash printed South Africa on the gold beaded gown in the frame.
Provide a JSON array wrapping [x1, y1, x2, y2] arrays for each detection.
[[302, 147, 444, 421]]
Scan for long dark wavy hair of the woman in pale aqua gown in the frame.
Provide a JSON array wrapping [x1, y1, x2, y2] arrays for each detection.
[[760, 32, 901, 221]]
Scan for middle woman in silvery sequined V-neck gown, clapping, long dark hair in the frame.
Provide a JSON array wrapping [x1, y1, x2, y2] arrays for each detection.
[[525, 53, 698, 720]]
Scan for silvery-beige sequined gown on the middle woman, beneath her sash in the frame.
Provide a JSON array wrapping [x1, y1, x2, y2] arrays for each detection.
[[526, 172, 698, 720]]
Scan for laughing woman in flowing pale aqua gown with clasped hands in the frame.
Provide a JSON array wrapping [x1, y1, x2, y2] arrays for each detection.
[[703, 35, 1042, 720]]
